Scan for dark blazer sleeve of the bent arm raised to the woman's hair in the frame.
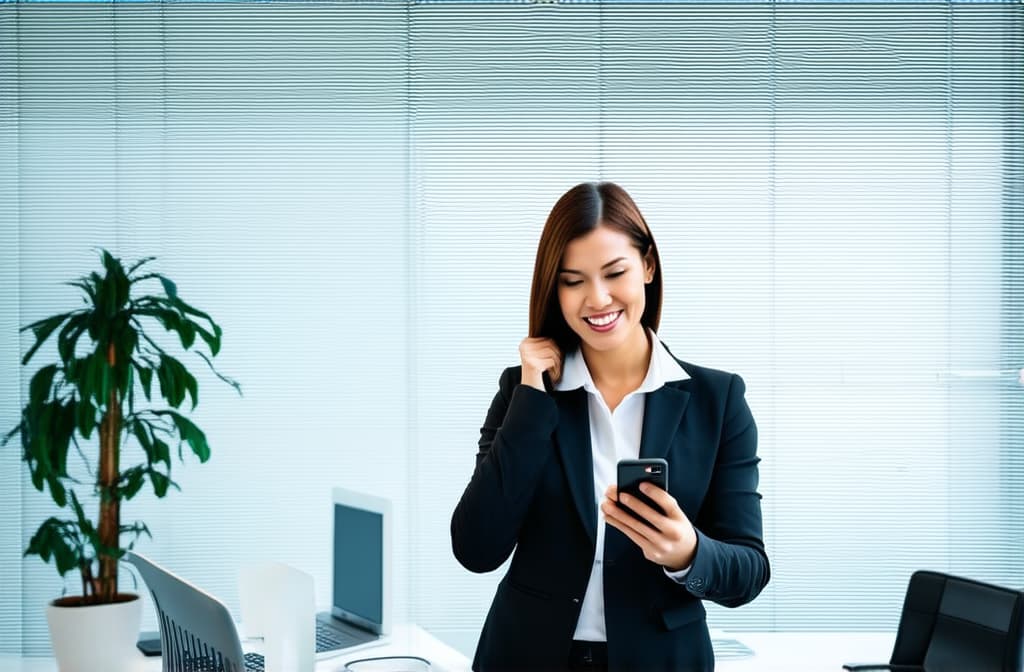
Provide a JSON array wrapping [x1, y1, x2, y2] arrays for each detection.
[[452, 367, 558, 573]]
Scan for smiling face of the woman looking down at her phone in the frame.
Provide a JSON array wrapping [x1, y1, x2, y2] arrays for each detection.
[[558, 226, 654, 350]]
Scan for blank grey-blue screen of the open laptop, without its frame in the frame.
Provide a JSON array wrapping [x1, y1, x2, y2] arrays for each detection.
[[334, 502, 384, 625]]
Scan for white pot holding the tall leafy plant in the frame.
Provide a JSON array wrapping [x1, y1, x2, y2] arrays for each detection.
[[46, 596, 142, 672]]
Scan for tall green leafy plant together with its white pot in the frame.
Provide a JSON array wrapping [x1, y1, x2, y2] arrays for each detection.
[[2, 250, 241, 672]]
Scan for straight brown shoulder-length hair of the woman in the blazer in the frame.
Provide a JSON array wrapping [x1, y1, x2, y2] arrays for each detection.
[[529, 182, 662, 353]]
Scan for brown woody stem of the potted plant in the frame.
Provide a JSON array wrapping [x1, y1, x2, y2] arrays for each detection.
[[97, 343, 121, 602]]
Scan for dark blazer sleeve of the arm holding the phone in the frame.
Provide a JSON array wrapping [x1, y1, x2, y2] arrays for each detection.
[[684, 374, 770, 606]]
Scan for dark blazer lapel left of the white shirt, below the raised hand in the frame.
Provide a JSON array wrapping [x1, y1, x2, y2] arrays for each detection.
[[555, 388, 597, 544]]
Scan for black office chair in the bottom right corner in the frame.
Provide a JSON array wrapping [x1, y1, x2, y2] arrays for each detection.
[[843, 571, 1024, 672]]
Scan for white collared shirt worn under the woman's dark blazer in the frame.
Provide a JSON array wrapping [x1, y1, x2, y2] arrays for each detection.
[[554, 329, 690, 641]]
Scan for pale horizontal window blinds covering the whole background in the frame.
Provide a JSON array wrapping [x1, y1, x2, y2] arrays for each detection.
[[0, 2, 1024, 653]]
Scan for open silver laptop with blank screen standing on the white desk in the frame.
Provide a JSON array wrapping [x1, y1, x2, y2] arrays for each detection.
[[316, 488, 391, 660]]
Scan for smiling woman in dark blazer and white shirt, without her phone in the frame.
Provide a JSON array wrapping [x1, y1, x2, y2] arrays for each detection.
[[452, 182, 769, 671]]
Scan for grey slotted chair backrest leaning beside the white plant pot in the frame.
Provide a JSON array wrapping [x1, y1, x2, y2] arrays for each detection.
[[124, 552, 245, 672]]
